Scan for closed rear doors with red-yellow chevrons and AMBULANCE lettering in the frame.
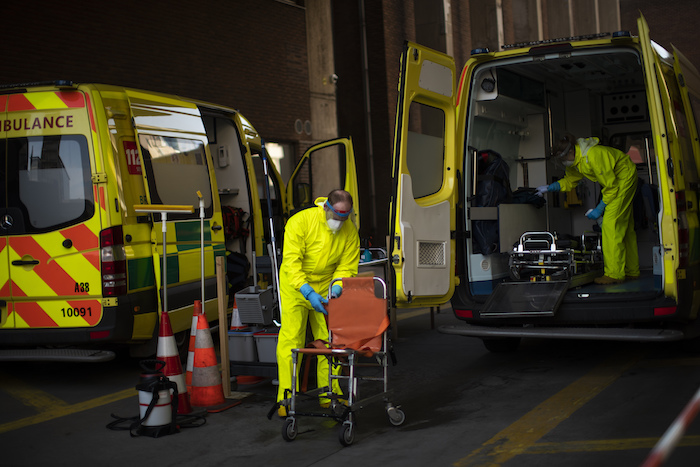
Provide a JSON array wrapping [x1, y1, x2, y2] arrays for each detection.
[[0, 87, 102, 332]]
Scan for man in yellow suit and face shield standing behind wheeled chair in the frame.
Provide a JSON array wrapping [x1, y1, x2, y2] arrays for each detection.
[[277, 190, 360, 416]]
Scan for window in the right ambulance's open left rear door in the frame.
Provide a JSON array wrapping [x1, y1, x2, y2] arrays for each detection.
[[406, 102, 445, 198]]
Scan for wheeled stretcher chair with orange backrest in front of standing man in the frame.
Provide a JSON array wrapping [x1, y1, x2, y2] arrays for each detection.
[[282, 277, 406, 446]]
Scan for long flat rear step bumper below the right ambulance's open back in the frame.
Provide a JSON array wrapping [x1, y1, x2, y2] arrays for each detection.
[[438, 324, 685, 342]]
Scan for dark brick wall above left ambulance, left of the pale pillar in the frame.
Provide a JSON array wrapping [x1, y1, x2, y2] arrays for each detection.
[[0, 0, 310, 149]]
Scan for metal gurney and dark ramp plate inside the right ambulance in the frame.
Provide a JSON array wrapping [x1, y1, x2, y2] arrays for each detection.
[[481, 232, 603, 318]]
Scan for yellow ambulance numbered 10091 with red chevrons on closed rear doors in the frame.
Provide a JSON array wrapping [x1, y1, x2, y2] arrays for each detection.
[[0, 81, 357, 360]]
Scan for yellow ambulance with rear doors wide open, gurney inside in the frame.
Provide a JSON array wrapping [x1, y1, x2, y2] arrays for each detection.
[[390, 17, 700, 351]]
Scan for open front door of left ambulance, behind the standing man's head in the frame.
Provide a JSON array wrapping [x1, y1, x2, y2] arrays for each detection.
[[286, 138, 360, 230]]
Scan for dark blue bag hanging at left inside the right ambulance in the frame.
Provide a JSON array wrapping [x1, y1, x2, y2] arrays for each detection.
[[472, 149, 513, 255]]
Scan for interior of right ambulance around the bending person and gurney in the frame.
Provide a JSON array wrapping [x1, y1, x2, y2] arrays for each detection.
[[463, 48, 661, 295]]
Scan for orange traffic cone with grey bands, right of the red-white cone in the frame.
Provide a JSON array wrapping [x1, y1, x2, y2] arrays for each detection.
[[190, 315, 241, 412]]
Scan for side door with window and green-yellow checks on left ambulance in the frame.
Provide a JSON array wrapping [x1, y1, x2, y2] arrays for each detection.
[[126, 90, 225, 332]]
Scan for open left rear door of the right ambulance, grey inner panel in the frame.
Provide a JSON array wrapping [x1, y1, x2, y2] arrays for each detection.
[[390, 42, 458, 307]]
